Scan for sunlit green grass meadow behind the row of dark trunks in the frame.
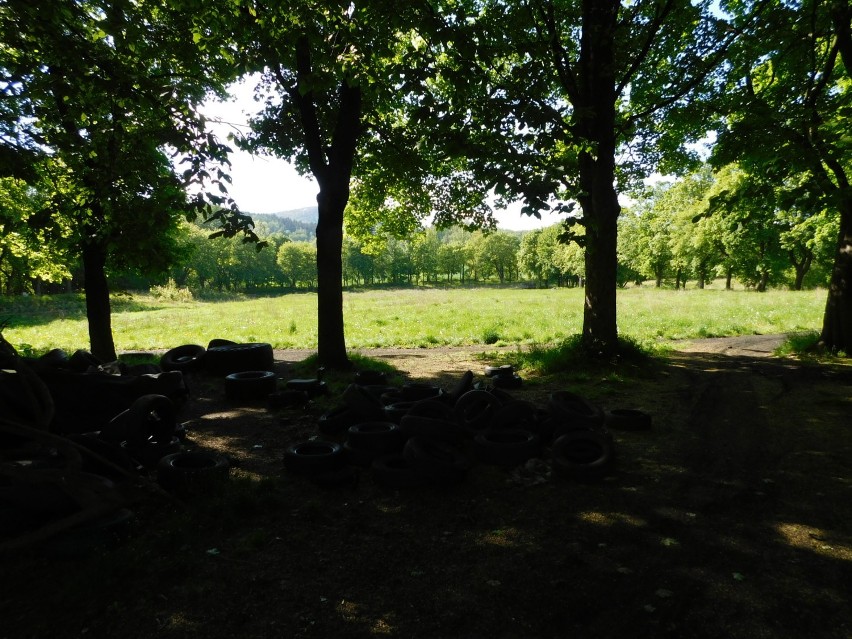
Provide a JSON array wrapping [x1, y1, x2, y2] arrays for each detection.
[[0, 287, 826, 353]]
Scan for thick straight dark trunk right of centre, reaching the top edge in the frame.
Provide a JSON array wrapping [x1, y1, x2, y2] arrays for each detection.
[[572, 0, 621, 354]]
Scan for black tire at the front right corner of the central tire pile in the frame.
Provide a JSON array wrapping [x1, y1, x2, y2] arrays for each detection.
[[551, 430, 615, 482]]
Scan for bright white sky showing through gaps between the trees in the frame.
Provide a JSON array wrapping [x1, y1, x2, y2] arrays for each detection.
[[202, 82, 564, 231]]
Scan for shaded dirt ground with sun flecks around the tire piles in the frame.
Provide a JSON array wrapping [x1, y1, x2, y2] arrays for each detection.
[[0, 336, 852, 639]]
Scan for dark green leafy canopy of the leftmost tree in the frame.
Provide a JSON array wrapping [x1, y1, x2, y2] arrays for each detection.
[[0, 0, 260, 260]]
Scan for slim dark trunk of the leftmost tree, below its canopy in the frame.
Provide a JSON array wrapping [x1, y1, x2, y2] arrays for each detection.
[[83, 242, 118, 362]]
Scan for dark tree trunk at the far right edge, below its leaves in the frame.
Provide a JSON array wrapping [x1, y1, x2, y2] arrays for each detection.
[[820, 195, 852, 355]]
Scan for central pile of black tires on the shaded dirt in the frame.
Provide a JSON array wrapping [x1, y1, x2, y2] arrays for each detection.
[[284, 371, 651, 488]]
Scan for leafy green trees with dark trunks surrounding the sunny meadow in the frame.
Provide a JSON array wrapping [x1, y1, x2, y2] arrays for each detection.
[[0, 0, 852, 356]]
